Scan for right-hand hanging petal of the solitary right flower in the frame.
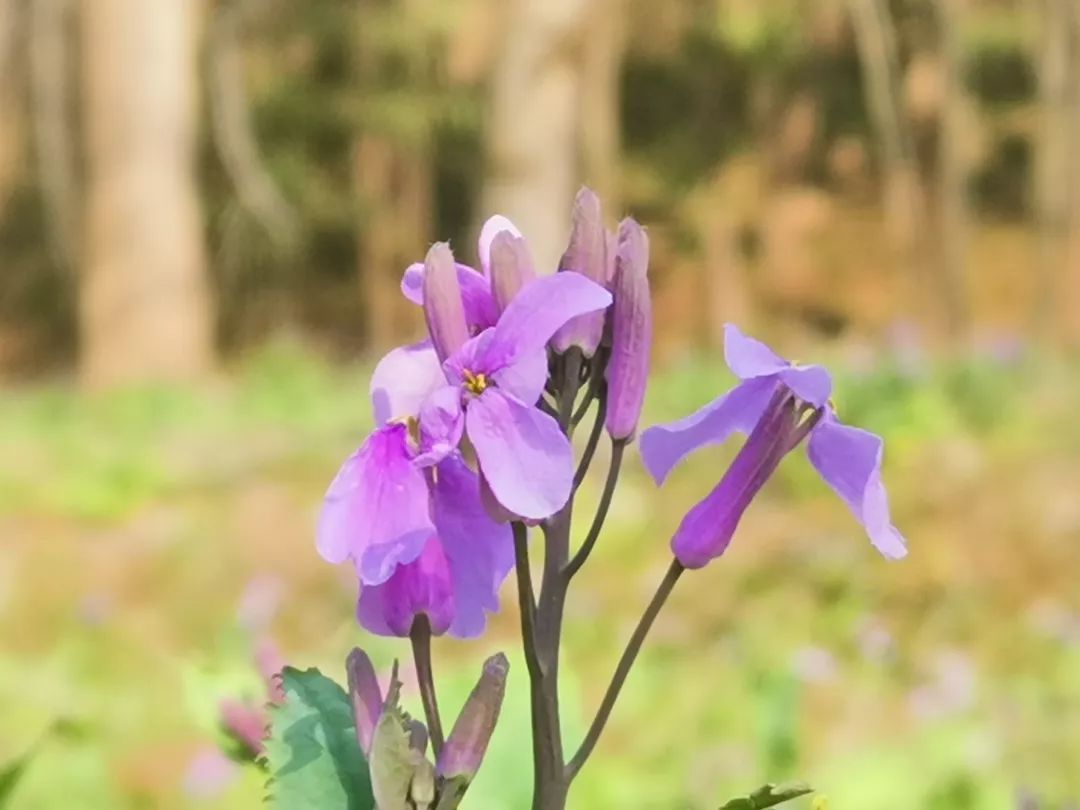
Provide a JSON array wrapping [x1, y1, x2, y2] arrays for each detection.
[[808, 413, 907, 559]]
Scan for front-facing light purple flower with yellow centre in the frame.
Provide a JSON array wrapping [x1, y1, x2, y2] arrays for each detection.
[[420, 273, 611, 519]]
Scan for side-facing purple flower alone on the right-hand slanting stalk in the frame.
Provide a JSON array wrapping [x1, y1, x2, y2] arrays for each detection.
[[642, 324, 907, 568]]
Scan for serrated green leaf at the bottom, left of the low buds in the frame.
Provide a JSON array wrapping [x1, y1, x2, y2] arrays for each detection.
[[267, 666, 375, 810]]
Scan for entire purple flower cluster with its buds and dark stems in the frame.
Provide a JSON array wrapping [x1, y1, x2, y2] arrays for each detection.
[[293, 189, 906, 807]]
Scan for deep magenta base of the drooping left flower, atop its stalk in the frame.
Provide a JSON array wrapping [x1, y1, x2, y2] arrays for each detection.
[[356, 535, 454, 637]]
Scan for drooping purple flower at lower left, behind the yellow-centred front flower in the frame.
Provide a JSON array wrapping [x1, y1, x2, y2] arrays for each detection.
[[318, 343, 513, 637]]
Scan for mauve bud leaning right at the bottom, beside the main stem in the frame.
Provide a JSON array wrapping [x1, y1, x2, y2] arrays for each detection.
[[437, 652, 510, 784]]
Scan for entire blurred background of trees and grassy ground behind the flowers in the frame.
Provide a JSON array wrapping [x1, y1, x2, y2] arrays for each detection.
[[0, 0, 1080, 810]]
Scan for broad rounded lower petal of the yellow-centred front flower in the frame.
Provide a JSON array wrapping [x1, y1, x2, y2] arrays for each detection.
[[465, 390, 580, 519]]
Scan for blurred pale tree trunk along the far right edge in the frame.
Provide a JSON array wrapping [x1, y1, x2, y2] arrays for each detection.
[[1032, 0, 1078, 339]]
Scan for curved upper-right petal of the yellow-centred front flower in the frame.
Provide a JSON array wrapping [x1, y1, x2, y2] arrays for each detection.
[[488, 273, 611, 370]]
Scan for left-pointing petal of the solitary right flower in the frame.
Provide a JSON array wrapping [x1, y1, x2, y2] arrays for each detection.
[[642, 377, 777, 484]]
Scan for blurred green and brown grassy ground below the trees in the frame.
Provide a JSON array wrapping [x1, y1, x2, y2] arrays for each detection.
[[0, 341, 1080, 810]]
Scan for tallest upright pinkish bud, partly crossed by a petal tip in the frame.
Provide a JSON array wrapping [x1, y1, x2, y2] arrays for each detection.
[[551, 187, 607, 357]]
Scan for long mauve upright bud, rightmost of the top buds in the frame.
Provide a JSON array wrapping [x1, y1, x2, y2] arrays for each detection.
[[606, 217, 652, 441]]
